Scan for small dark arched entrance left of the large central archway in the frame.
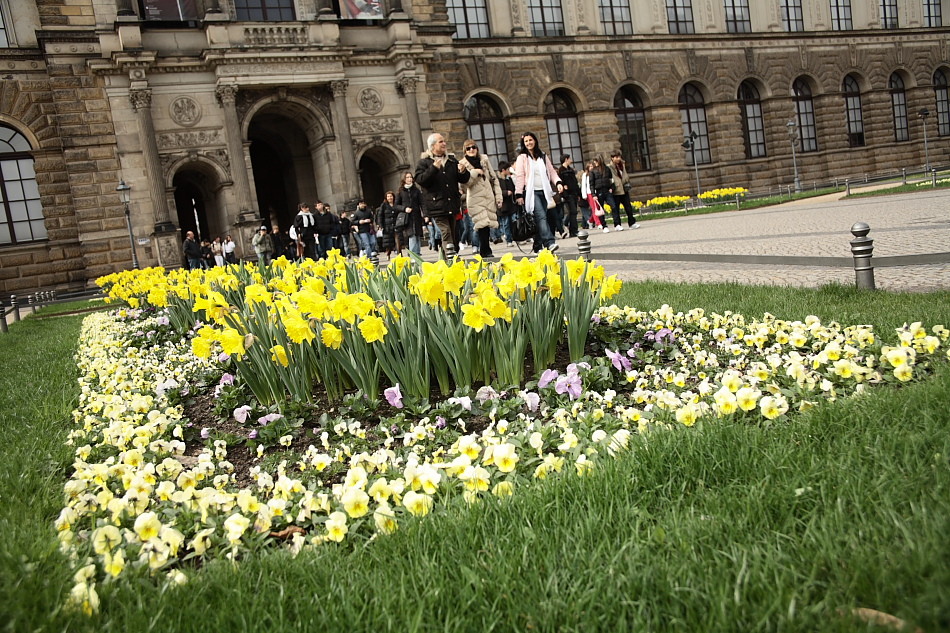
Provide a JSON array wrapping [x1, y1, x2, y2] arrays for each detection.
[[172, 162, 228, 240]]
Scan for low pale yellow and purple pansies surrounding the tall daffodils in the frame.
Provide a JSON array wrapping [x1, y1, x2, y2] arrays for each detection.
[[56, 253, 950, 612]]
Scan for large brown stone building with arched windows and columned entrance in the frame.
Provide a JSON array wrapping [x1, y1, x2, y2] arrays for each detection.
[[0, 0, 950, 297]]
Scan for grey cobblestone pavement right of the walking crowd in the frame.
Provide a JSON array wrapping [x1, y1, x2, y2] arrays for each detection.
[[414, 189, 950, 291]]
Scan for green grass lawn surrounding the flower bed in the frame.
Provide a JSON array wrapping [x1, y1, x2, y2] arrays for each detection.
[[0, 283, 950, 631]]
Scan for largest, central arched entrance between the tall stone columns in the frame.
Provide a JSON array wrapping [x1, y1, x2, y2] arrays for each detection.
[[247, 100, 330, 230]]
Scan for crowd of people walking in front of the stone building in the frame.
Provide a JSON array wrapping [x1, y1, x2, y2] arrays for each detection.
[[183, 132, 640, 268]]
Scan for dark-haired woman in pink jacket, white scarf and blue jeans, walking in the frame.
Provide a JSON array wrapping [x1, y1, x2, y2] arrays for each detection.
[[515, 132, 563, 253]]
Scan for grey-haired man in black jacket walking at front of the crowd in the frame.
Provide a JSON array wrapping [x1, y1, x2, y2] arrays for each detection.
[[415, 132, 471, 257]]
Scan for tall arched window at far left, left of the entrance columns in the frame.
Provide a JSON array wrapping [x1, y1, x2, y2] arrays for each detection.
[[0, 124, 46, 245]]
